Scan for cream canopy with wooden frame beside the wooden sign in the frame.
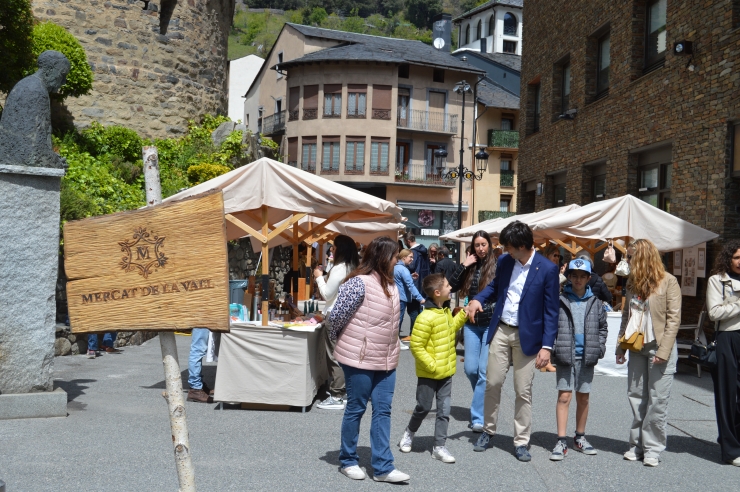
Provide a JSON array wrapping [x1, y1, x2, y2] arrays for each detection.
[[165, 157, 402, 325]]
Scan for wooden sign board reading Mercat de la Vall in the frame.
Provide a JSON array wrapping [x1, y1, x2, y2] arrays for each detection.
[[64, 191, 229, 333]]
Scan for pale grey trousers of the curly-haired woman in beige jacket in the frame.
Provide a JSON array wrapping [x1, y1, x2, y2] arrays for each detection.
[[627, 342, 678, 458]]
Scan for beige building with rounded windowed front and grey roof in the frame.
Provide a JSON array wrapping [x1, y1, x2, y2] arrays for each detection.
[[245, 24, 485, 250]]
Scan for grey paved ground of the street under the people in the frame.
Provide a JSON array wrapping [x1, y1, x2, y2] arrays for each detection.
[[0, 322, 740, 492]]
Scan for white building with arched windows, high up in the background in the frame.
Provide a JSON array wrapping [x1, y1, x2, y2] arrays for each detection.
[[452, 0, 524, 56]]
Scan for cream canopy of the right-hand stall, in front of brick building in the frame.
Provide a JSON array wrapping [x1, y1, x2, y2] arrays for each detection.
[[530, 195, 718, 253]]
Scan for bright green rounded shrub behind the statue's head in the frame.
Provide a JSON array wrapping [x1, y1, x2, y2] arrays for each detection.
[[27, 22, 93, 99]]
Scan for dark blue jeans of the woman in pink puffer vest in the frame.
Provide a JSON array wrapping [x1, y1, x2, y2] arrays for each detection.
[[339, 362, 396, 476]]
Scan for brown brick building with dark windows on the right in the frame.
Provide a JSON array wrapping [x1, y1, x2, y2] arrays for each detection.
[[518, 0, 740, 320]]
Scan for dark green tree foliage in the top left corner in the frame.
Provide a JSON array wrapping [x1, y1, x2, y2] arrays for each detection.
[[0, 0, 35, 93]]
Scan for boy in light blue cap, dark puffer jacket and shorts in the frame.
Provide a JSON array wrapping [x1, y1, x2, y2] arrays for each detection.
[[550, 259, 607, 461]]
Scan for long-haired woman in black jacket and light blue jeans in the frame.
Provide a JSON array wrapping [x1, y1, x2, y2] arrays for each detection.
[[450, 231, 496, 432]]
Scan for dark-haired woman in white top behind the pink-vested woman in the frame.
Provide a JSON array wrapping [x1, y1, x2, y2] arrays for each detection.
[[313, 234, 360, 410]]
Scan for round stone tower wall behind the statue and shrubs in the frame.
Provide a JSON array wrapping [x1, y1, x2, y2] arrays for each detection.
[[32, 0, 234, 138]]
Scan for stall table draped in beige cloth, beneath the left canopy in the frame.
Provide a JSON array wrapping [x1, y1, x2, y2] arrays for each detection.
[[213, 322, 327, 412]]
